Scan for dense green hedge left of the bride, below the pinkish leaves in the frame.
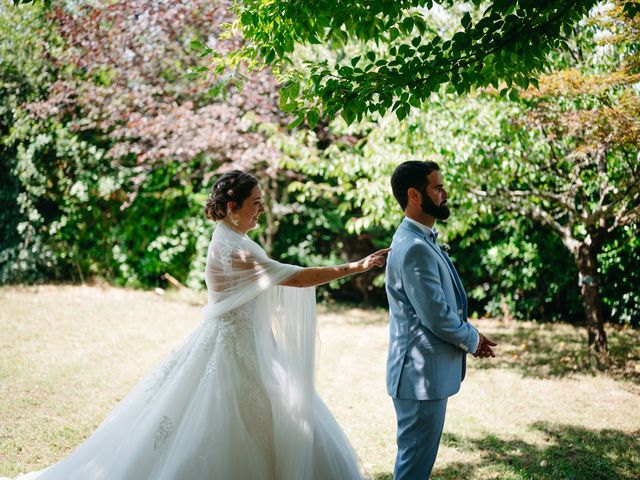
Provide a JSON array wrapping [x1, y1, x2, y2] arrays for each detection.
[[0, 109, 210, 286]]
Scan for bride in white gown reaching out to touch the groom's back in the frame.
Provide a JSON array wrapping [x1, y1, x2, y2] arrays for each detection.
[[10, 171, 387, 480]]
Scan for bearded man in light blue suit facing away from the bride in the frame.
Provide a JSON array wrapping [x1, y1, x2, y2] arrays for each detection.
[[386, 161, 496, 480]]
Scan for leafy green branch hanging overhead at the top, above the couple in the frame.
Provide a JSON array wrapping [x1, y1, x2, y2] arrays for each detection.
[[216, 0, 616, 126]]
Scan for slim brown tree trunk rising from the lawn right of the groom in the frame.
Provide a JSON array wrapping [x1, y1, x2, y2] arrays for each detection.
[[574, 242, 607, 353]]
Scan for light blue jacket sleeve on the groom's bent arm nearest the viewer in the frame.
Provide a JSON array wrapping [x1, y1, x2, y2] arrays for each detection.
[[402, 243, 480, 353]]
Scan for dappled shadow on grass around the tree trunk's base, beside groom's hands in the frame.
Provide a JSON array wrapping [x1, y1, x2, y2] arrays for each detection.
[[473, 322, 640, 385]]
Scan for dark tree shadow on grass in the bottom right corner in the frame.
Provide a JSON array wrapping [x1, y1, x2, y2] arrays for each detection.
[[436, 422, 640, 480]]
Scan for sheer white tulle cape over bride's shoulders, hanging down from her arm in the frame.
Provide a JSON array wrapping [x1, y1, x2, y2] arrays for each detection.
[[205, 222, 316, 479]]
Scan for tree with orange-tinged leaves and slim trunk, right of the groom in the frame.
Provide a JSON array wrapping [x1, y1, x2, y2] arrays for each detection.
[[471, 0, 640, 351]]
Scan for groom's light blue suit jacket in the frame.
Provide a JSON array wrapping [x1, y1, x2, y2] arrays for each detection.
[[386, 219, 479, 400]]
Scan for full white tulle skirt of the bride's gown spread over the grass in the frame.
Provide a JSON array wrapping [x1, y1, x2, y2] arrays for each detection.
[[12, 311, 361, 480]]
